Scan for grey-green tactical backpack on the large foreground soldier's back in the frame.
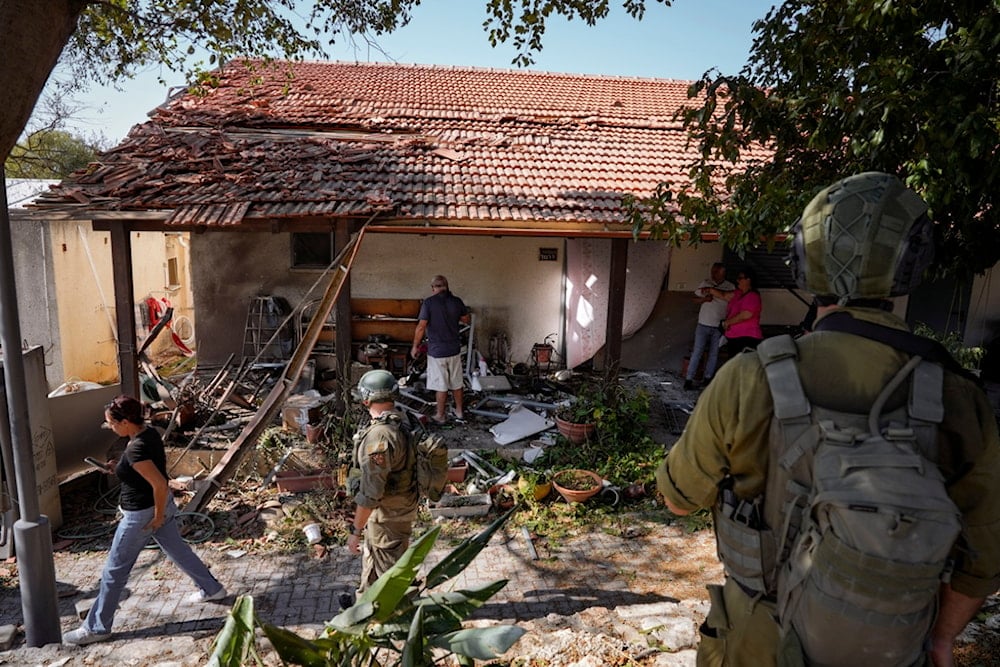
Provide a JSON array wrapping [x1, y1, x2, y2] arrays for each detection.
[[716, 336, 960, 666]]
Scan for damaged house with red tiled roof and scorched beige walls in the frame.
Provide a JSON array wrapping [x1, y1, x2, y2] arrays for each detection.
[[17, 62, 995, 470]]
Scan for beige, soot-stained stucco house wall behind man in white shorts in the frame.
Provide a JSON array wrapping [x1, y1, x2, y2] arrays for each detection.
[[191, 232, 565, 366]]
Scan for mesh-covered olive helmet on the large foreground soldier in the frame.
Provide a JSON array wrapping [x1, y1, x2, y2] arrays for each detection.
[[789, 171, 934, 304]]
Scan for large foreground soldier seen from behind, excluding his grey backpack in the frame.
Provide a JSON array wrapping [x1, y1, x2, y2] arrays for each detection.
[[656, 172, 1000, 667]]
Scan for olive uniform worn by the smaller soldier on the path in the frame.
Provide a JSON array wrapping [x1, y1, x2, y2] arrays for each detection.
[[354, 410, 419, 594]]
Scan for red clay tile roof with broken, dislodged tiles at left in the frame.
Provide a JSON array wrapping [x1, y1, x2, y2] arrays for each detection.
[[33, 62, 752, 229]]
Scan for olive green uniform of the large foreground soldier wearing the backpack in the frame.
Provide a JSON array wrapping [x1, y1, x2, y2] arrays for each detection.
[[656, 308, 1000, 667]]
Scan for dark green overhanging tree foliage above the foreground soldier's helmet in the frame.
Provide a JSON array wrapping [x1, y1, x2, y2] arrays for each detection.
[[648, 0, 1000, 278]]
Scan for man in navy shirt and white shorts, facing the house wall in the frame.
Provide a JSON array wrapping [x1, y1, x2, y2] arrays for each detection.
[[410, 276, 469, 424]]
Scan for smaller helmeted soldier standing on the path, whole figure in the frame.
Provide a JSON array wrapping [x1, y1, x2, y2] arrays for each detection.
[[340, 370, 419, 607]]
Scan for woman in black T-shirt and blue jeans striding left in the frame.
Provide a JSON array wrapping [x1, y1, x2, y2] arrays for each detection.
[[63, 395, 227, 646]]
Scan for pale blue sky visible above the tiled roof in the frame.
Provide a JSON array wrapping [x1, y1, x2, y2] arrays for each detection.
[[70, 0, 773, 144]]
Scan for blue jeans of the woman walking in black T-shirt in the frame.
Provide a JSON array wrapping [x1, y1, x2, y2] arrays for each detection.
[[83, 499, 222, 634]]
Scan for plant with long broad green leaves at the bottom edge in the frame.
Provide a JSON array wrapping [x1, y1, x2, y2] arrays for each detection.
[[209, 510, 524, 667]]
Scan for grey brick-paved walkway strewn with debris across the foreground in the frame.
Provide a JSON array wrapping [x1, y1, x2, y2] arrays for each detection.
[[0, 516, 713, 665]]
